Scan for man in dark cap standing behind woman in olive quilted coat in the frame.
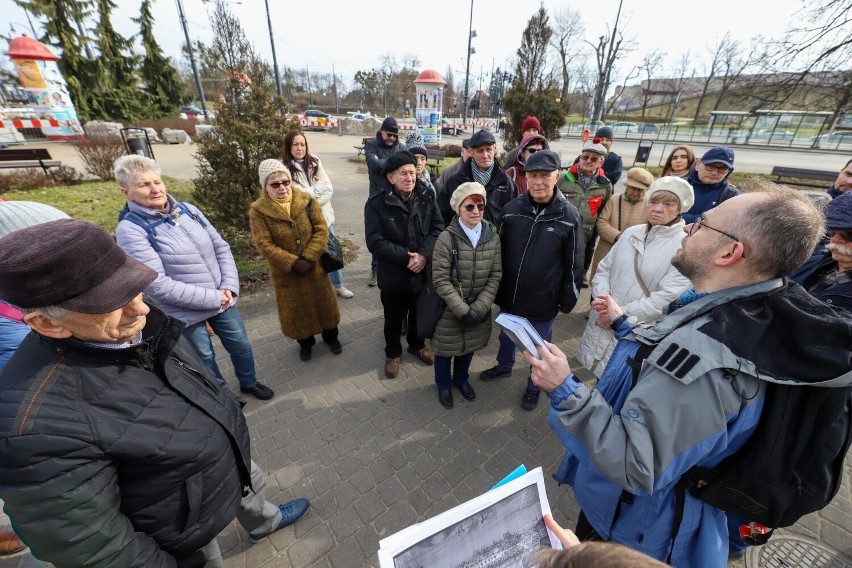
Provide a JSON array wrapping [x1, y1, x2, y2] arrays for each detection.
[[438, 130, 518, 229]]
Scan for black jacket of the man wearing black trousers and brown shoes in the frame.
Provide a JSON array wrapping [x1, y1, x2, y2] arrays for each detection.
[[364, 180, 444, 293]]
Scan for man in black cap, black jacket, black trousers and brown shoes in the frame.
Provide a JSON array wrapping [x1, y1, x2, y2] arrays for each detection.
[[364, 150, 444, 379]]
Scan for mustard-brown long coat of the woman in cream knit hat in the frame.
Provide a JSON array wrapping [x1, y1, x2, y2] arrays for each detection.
[[249, 187, 340, 339]]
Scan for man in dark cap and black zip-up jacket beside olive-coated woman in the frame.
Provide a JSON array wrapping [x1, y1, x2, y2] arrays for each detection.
[[479, 150, 584, 410]]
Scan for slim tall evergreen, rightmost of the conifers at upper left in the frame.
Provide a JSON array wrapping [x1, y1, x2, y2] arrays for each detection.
[[133, 0, 184, 117]]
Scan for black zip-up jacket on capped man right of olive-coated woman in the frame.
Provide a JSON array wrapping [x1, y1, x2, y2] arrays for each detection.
[[497, 190, 585, 321]]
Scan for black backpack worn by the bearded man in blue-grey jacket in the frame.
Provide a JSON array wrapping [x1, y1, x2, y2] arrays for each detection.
[[627, 328, 852, 544]]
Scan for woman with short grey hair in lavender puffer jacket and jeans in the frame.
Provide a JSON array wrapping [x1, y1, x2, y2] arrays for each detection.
[[113, 154, 274, 400]]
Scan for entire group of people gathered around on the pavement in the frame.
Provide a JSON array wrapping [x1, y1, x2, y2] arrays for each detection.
[[0, 113, 852, 567]]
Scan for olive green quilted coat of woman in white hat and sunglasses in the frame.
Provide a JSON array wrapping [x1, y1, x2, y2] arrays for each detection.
[[432, 217, 503, 357]]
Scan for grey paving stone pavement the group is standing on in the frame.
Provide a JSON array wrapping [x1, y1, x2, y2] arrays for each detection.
[[0, 133, 852, 568]]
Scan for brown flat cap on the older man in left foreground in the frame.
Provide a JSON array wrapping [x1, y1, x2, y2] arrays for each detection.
[[0, 219, 157, 314]]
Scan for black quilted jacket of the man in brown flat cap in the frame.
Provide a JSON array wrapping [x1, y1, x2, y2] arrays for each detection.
[[0, 308, 251, 568]]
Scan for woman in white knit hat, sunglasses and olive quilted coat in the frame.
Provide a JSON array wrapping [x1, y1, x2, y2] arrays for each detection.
[[432, 182, 503, 408]]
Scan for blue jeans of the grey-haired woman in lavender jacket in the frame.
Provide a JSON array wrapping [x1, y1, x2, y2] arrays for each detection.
[[183, 306, 257, 388]]
